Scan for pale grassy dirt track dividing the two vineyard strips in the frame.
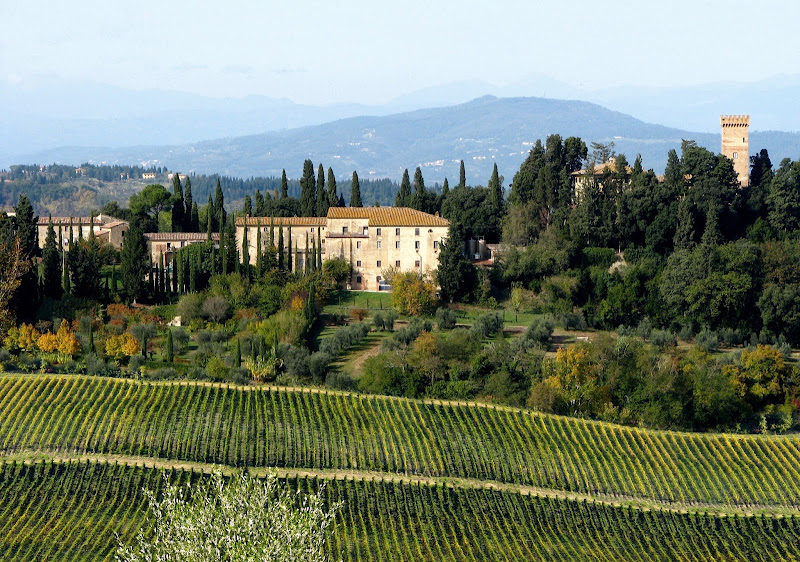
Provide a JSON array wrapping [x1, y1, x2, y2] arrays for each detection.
[[0, 450, 800, 518]]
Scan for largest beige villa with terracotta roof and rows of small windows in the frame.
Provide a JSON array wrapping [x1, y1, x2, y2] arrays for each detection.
[[236, 207, 450, 291]]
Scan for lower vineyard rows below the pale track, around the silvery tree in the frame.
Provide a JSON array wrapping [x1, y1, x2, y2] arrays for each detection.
[[0, 462, 800, 562]]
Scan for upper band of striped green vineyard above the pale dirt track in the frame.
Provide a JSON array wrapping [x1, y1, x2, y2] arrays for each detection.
[[0, 376, 800, 511]]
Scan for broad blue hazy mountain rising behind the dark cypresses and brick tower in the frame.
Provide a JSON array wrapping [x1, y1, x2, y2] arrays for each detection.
[[14, 95, 800, 185]]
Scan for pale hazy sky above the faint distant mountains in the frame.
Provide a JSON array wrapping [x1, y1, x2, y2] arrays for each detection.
[[0, 0, 800, 104]]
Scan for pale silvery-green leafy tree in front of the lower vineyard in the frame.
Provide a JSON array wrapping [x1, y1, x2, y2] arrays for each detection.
[[116, 473, 340, 562]]
